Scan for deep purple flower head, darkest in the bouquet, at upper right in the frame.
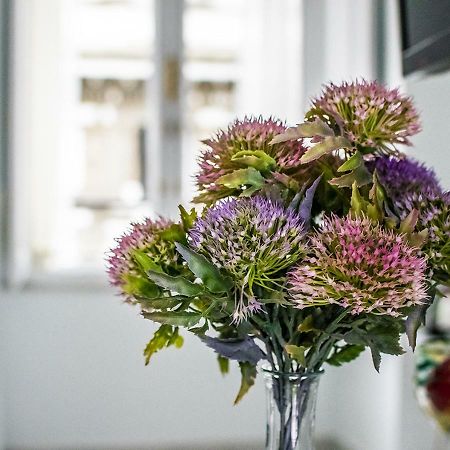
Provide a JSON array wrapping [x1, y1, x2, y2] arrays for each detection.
[[367, 156, 441, 202]]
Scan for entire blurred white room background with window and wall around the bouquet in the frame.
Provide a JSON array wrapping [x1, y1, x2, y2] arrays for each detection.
[[0, 0, 450, 450]]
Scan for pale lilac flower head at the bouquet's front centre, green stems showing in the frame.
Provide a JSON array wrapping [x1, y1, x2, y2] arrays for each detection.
[[189, 196, 305, 321]]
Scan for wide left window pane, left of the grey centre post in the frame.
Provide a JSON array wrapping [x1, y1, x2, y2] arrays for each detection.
[[32, 0, 154, 270]]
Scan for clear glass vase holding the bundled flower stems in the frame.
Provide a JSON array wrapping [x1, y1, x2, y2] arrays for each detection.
[[262, 369, 322, 450]]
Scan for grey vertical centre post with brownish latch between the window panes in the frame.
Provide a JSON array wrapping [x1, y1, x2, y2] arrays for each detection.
[[146, 0, 184, 217]]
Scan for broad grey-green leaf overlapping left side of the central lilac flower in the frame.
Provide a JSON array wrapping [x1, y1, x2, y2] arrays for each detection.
[[175, 243, 233, 294]]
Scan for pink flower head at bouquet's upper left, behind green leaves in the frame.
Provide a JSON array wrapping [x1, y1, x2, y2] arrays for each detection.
[[196, 117, 317, 203]]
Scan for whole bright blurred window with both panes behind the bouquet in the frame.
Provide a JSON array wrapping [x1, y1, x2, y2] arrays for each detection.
[[5, 0, 302, 282]]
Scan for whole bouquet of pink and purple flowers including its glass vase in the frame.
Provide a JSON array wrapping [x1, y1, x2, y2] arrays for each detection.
[[108, 81, 450, 450]]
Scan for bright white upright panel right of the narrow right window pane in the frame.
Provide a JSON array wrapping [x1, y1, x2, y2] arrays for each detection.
[[237, 0, 304, 123]]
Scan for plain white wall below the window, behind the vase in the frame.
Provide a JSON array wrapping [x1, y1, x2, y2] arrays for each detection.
[[0, 286, 408, 450]]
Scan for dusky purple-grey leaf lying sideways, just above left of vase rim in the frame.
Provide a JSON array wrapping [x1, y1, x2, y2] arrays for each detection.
[[199, 336, 266, 365]]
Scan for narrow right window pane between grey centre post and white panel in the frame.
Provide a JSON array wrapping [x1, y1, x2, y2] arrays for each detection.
[[183, 0, 245, 201]]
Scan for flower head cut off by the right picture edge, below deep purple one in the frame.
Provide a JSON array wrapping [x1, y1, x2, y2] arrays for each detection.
[[397, 189, 450, 284]]
